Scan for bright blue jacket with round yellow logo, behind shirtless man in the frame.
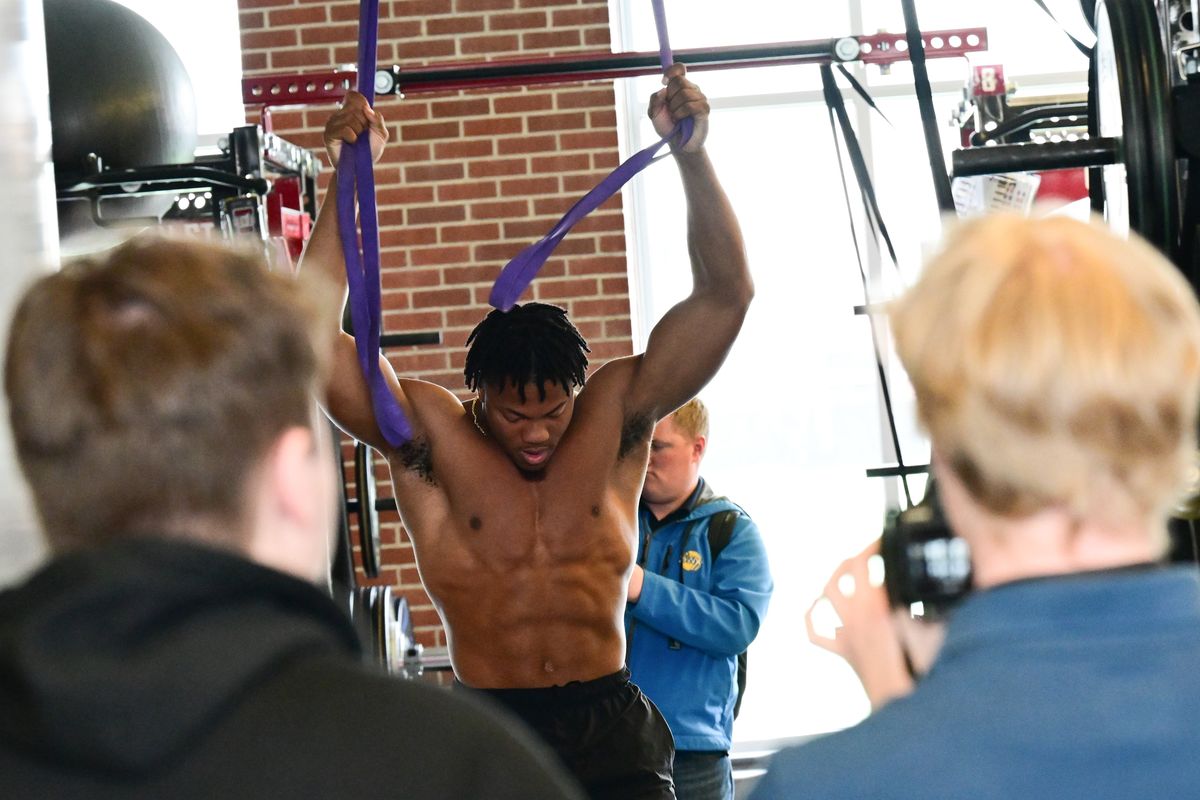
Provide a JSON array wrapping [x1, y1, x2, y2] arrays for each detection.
[[625, 480, 774, 751]]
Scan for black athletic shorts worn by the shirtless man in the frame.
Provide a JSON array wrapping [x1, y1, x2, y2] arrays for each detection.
[[460, 669, 674, 800]]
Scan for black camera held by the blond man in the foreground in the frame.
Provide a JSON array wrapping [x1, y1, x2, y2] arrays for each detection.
[[880, 479, 972, 620]]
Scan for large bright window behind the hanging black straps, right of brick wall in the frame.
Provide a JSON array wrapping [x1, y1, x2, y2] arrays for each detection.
[[613, 0, 1086, 745]]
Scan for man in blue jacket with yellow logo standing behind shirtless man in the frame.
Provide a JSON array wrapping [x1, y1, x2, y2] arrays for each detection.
[[625, 398, 773, 800]]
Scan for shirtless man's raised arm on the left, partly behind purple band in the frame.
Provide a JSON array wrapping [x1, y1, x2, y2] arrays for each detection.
[[300, 91, 409, 450]]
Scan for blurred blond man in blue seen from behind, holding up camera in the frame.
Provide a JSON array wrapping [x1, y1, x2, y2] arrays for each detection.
[[755, 216, 1200, 800]]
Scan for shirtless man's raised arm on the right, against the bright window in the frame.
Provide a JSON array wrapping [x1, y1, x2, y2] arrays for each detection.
[[626, 64, 754, 420]]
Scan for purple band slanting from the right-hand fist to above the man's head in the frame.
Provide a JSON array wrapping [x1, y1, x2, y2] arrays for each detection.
[[487, 0, 694, 311]]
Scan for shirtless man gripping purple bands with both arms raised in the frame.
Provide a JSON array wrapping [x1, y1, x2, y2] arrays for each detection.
[[304, 65, 754, 799]]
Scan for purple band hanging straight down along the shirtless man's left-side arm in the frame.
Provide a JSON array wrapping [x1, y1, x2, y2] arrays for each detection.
[[337, 0, 413, 447]]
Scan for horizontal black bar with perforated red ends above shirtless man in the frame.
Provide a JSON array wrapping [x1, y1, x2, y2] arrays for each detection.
[[241, 28, 988, 106]]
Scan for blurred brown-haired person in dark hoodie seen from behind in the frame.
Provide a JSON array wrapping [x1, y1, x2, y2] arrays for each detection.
[[0, 237, 581, 800]]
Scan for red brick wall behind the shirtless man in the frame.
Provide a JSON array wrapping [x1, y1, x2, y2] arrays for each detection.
[[232, 0, 631, 646]]
